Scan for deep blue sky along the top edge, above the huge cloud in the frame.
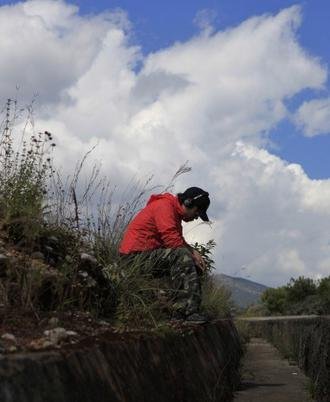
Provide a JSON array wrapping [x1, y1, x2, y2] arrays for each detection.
[[70, 0, 330, 55]]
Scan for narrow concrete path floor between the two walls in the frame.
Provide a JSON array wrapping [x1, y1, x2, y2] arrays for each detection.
[[234, 338, 311, 402]]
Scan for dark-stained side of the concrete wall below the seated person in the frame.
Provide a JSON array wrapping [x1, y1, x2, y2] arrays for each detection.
[[0, 320, 241, 402]]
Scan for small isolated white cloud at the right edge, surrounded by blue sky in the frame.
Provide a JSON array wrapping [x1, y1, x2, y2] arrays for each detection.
[[294, 98, 330, 137]]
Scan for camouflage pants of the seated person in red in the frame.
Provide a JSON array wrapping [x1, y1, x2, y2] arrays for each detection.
[[121, 247, 201, 315]]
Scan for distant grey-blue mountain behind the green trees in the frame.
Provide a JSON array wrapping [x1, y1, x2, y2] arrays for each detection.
[[214, 274, 268, 308]]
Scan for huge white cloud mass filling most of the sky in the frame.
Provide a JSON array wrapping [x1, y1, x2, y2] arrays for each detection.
[[0, 0, 330, 284]]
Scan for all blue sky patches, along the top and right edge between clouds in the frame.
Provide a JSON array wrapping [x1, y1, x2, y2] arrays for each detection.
[[69, 0, 330, 179]]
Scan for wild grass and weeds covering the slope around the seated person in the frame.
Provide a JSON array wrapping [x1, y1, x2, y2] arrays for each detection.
[[0, 99, 229, 352]]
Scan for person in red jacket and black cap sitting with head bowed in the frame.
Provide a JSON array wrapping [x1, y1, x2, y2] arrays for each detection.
[[119, 187, 210, 322]]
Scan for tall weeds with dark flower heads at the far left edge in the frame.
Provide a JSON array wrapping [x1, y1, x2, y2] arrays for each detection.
[[0, 99, 55, 245]]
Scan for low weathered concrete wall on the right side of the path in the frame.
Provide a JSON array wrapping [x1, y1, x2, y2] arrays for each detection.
[[240, 316, 330, 402]]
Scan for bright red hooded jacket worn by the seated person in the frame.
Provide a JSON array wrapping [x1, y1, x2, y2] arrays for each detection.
[[119, 193, 187, 254]]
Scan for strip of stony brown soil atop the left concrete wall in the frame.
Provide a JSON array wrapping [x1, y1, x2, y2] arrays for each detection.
[[0, 308, 189, 356]]
